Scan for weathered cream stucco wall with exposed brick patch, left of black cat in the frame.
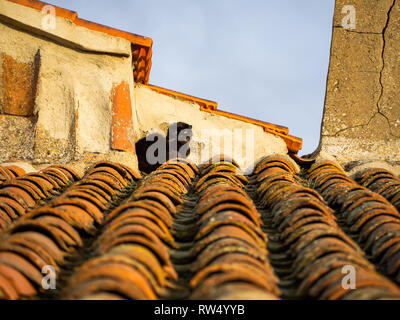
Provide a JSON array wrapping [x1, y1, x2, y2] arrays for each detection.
[[0, 1, 137, 172]]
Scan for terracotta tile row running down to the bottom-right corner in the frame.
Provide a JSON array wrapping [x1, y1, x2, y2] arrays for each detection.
[[250, 157, 400, 299]]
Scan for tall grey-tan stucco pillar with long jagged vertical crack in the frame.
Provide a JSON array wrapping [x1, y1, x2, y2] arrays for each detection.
[[320, 0, 400, 164]]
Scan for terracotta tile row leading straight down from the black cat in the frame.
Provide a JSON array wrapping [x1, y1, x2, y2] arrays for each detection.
[[63, 162, 194, 299]]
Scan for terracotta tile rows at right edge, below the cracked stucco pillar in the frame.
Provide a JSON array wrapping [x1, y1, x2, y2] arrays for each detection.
[[308, 162, 400, 283]]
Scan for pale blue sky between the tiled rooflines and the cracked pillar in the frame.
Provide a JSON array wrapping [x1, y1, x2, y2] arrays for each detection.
[[47, 0, 334, 154]]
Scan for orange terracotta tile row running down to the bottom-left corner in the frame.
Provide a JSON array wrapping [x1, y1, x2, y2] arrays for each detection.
[[0, 164, 138, 298]]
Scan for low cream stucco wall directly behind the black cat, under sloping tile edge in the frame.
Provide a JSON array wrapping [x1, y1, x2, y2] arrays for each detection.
[[135, 85, 287, 169]]
